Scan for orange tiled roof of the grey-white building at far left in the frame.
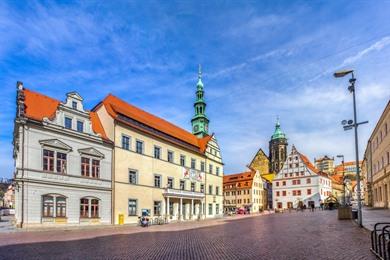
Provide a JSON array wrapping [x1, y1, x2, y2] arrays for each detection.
[[23, 89, 108, 140]]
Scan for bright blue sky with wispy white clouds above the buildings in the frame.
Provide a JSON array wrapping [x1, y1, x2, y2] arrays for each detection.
[[0, 0, 390, 178]]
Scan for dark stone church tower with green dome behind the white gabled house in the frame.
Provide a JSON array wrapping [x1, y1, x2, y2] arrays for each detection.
[[269, 118, 288, 173]]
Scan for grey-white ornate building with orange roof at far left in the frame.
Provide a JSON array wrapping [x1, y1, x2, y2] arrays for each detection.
[[13, 82, 112, 227]]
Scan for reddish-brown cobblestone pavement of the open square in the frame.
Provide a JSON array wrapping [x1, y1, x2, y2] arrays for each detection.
[[0, 211, 375, 260]]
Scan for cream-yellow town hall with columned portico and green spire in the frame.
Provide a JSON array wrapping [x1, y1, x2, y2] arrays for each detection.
[[93, 71, 223, 224]]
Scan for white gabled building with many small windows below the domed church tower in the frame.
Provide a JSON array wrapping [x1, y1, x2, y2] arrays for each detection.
[[272, 146, 332, 209]]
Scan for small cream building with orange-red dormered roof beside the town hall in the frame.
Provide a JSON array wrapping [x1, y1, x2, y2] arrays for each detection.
[[223, 170, 266, 213]]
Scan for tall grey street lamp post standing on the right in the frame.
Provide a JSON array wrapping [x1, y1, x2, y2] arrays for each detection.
[[333, 70, 368, 227]]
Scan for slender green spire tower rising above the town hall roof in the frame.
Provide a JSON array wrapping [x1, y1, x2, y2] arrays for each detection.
[[191, 65, 209, 137]]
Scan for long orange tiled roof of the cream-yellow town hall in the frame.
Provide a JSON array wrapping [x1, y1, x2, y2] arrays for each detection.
[[97, 94, 212, 153]]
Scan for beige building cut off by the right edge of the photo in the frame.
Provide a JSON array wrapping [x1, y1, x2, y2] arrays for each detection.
[[362, 101, 390, 208]]
